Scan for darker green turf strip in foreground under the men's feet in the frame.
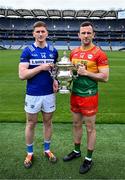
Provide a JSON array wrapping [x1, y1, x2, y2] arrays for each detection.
[[0, 123, 125, 179]]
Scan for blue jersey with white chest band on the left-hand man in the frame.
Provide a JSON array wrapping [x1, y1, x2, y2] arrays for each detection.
[[20, 44, 58, 96]]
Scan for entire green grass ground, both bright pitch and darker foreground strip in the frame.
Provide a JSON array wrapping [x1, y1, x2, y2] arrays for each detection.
[[0, 50, 125, 179]]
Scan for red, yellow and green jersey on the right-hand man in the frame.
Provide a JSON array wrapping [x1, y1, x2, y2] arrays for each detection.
[[70, 46, 108, 96]]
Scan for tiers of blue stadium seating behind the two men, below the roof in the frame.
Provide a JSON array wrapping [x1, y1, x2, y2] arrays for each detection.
[[0, 17, 125, 50]]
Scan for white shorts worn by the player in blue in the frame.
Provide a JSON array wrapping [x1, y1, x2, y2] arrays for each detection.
[[24, 94, 56, 114]]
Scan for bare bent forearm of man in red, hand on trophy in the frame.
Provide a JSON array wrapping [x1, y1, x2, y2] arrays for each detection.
[[78, 66, 109, 82]]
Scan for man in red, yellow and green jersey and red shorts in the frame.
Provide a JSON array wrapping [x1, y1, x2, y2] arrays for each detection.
[[63, 21, 109, 174]]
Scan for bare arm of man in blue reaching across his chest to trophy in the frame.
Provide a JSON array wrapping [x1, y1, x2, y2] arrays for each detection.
[[19, 63, 52, 80]]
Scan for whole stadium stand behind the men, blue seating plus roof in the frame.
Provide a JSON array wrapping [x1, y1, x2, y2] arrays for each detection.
[[0, 9, 125, 50]]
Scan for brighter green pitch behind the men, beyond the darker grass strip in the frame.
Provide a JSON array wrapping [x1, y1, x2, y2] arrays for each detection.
[[0, 50, 125, 123]]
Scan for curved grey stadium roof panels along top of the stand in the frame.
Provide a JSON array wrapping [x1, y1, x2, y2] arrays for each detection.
[[0, 8, 118, 19]]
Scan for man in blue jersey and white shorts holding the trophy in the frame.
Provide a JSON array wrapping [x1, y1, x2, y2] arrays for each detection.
[[19, 21, 58, 168]]
